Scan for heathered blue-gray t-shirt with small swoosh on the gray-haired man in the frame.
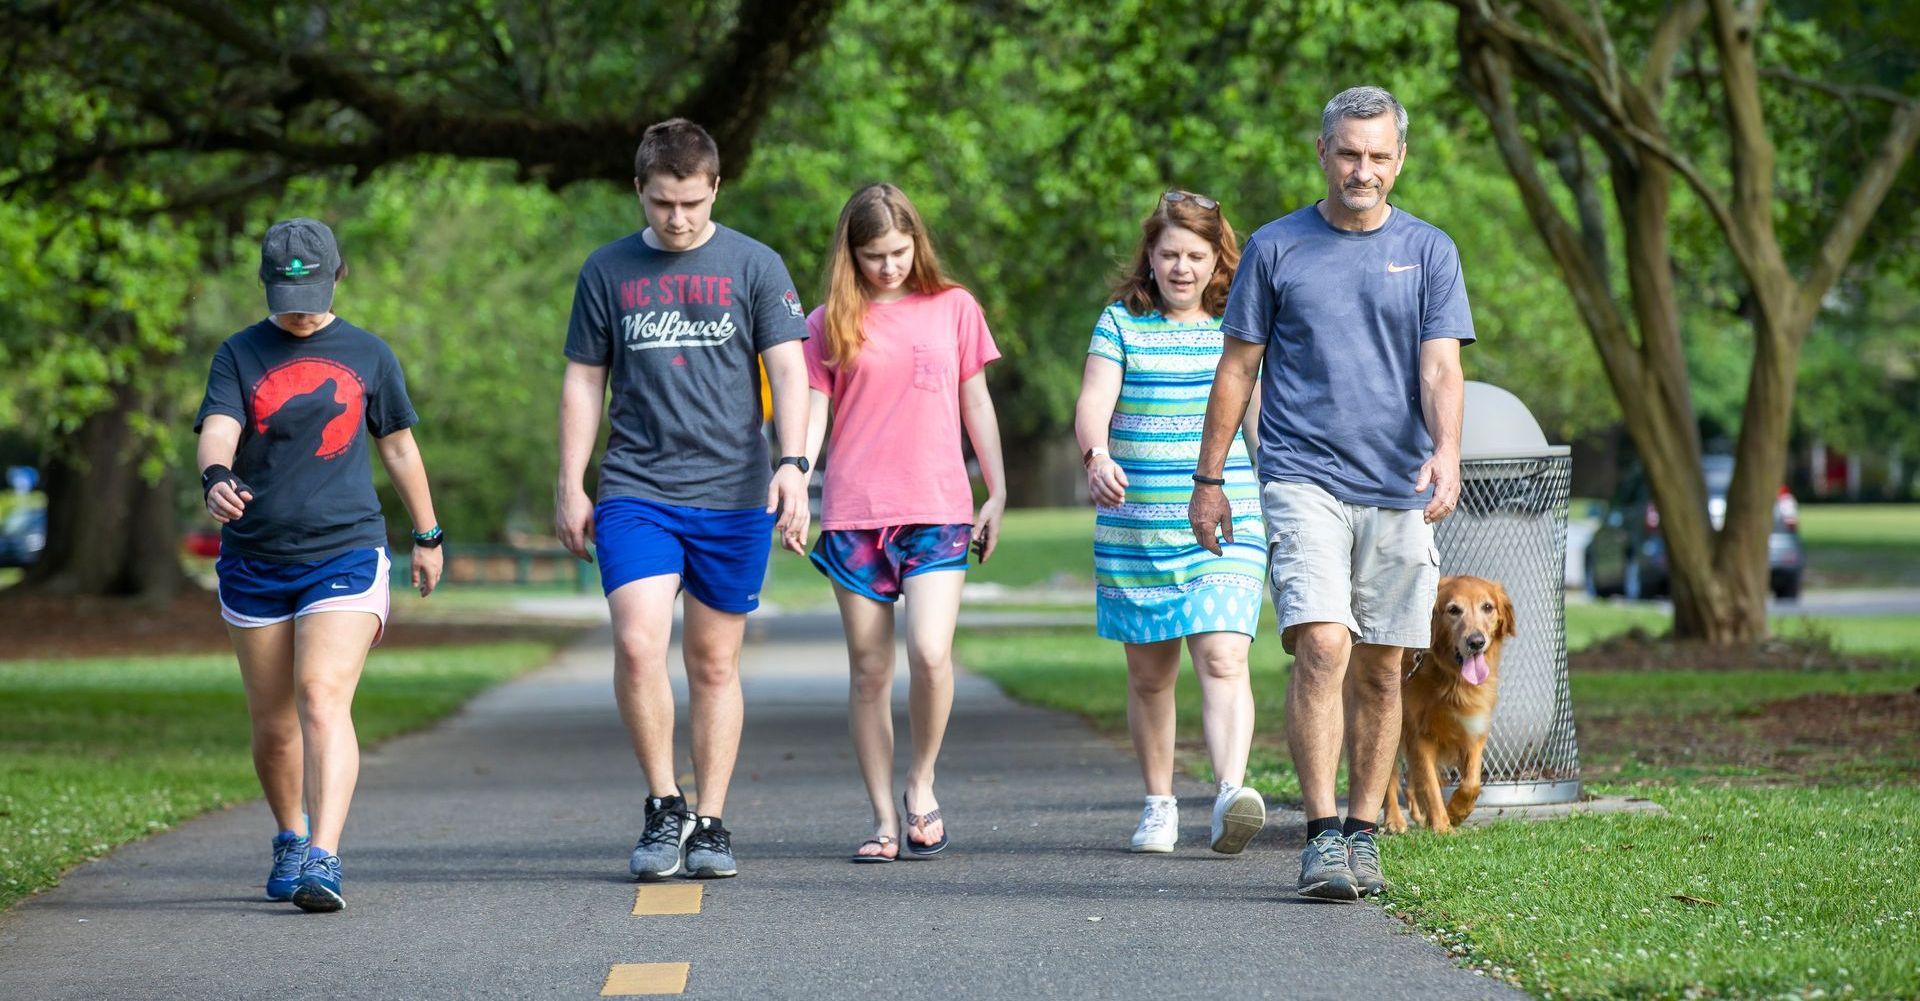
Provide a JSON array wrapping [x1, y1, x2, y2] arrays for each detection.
[[1221, 206, 1473, 509]]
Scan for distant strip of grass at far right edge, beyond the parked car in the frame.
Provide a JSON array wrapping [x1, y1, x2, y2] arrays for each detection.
[[1801, 503, 1920, 588]]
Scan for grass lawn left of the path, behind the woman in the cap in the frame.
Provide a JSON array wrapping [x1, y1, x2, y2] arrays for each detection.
[[0, 642, 553, 909]]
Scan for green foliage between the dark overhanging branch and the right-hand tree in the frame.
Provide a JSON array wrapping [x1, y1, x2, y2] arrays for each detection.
[[722, 0, 1613, 438]]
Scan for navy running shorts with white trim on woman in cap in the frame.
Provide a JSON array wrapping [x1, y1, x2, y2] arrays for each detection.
[[213, 546, 392, 644]]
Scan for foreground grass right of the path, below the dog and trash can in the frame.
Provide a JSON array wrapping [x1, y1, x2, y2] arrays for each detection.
[[1382, 784, 1920, 999]]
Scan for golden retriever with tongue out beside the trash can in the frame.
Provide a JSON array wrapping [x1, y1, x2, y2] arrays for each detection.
[[1384, 576, 1513, 834]]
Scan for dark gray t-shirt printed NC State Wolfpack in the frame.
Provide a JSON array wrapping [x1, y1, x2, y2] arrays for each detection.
[[566, 225, 806, 511]]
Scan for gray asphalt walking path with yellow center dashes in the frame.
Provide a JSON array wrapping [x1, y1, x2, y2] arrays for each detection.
[[0, 617, 1517, 999]]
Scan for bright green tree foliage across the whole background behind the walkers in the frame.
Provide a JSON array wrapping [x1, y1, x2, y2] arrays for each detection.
[[0, 0, 1920, 538]]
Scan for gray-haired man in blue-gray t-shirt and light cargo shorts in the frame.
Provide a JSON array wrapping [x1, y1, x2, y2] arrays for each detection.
[[1188, 86, 1473, 899]]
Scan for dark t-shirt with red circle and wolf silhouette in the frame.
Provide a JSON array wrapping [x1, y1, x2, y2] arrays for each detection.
[[194, 317, 419, 563]]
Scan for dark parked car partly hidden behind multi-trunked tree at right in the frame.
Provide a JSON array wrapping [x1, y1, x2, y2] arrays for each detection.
[[1586, 455, 1807, 601]]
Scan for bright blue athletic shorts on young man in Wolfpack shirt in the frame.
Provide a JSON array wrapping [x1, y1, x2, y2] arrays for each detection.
[[593, 498, 774, 611]]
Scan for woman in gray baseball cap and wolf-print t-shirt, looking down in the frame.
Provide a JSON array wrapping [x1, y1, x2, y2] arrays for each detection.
[[194, 219, 442, 911]]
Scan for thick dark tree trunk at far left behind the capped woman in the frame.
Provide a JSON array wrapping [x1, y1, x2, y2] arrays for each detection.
[[19, 374, 194, 601]]
